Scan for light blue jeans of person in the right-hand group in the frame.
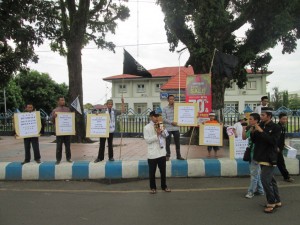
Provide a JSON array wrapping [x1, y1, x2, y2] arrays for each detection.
[[248, 160, 264, 194]]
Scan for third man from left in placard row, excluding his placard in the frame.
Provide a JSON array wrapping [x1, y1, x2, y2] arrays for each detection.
[[94, 97, 125, 163]]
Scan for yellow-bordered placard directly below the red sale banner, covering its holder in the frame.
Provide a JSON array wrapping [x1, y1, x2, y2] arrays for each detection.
[[199, 123, 223, 146]]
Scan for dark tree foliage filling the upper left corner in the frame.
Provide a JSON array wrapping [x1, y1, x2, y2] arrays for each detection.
[[0, 0, 55, 87]]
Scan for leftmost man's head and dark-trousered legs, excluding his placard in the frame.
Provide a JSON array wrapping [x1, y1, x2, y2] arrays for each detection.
[[21, 103, 41, 165]]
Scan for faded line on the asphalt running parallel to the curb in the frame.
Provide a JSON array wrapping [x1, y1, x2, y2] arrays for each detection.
[[0, 184, 300, 194]]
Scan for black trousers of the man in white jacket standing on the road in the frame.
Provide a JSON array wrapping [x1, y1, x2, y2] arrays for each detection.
[[148, 156, 167, 190]]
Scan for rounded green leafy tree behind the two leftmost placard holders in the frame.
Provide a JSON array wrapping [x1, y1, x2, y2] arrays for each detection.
[[14, 70, 68, 114]]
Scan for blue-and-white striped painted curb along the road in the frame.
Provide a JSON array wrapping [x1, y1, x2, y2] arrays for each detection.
[[0, 158, 300, 180]]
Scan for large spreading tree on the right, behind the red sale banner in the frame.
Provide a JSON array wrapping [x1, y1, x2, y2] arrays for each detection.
[[158, 0, 300, 109]]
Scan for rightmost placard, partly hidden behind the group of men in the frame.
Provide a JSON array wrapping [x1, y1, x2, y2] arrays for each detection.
[[229, 135, 248, 159]]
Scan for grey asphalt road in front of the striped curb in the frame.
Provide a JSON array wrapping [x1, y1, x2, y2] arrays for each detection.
[[0, 177, 300, 225]]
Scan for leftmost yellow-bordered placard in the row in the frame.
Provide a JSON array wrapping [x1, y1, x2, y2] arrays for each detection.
[[14, 111, 42, 139]]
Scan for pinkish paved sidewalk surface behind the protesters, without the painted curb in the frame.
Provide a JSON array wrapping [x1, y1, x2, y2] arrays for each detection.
[[0, 136, 229, 162]]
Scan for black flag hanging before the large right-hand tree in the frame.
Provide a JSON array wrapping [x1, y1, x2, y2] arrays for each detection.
[[213, 51, 239, 79]]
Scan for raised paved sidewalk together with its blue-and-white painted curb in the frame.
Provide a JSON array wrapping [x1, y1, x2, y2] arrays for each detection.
[[0, 136, 299, 180]]
